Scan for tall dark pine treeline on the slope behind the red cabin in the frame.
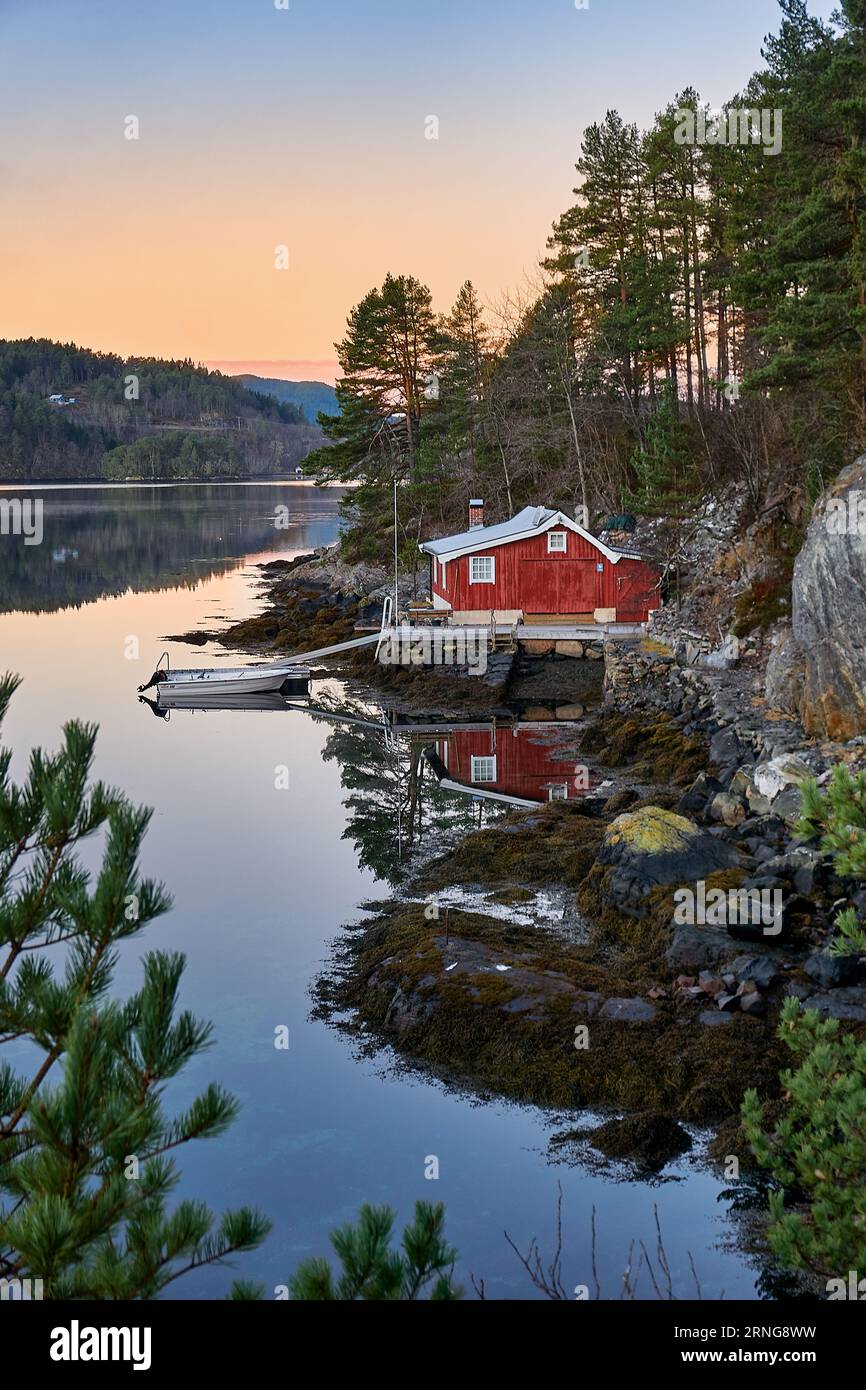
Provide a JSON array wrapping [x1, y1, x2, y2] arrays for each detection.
[[304, 0, 866, 575]]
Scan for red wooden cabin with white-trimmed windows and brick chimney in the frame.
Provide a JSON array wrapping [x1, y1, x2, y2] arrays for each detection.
[[421, 502, 662, 623]]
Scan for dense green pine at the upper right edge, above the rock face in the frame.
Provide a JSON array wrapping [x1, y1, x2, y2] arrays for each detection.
[[745, 0, 866, 430]]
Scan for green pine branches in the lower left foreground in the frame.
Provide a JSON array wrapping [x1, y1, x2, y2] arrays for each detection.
[[0, 676, 268, 1300]]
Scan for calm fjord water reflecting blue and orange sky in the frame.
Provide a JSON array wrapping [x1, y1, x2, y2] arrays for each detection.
[[0, 484, 755, 1298]]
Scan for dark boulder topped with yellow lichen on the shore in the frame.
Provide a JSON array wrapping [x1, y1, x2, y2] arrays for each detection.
[[598, 806, 741, 917]]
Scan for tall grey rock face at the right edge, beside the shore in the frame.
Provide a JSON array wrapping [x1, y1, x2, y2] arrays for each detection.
[[789, 455, 866, 739]]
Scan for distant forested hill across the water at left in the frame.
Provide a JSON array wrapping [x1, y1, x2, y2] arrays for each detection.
[[0, 338, 322, 482]]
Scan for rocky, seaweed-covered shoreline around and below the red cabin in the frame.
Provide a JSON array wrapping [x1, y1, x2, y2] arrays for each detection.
[[189, 500, 866, 1168]]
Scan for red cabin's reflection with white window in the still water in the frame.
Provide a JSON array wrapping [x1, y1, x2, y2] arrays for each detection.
[[427, 724, 598, 806]]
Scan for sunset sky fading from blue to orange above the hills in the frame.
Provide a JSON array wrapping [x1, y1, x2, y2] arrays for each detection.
[[0, 0, 833, 378]]
